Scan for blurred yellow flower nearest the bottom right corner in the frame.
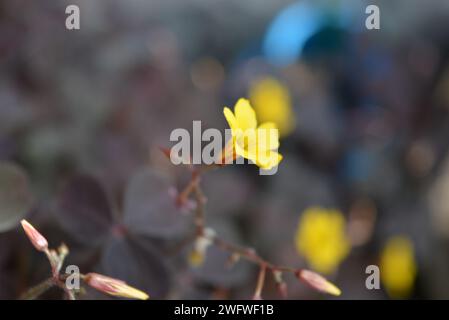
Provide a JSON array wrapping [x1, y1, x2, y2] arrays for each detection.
[[380, 236, 417, 298]]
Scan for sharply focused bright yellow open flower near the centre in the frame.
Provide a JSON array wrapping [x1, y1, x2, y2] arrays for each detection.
[[223, 99, 282, 170]]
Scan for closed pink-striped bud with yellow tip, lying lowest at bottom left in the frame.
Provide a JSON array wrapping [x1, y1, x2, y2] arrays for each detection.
[[84, 273, 150, 300]]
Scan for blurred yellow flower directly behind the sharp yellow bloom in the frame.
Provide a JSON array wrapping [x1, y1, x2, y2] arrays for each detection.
[[249, 77, 295, 137]]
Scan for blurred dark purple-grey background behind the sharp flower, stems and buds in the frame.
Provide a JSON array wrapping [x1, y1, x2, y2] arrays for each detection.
[[0, 0, 449, 299]]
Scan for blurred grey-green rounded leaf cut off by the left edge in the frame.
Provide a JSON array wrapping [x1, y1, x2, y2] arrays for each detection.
[[0, 162, 33, 232]]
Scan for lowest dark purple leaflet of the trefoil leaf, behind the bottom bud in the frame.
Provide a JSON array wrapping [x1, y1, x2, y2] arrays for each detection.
[[102, 237, 171, 299]]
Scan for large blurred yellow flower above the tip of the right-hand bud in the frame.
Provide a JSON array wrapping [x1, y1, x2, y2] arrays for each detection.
[[295, 207, 350, 274]]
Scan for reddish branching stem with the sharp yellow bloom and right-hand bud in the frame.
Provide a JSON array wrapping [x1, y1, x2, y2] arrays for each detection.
[[163, 99, 341, 300]]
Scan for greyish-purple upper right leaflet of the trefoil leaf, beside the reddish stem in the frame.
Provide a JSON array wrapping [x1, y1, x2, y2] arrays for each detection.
[[124, 169, 186, 238]]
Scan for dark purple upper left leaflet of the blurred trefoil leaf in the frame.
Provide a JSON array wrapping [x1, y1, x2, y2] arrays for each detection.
[[56, 175, 114, 245]]
